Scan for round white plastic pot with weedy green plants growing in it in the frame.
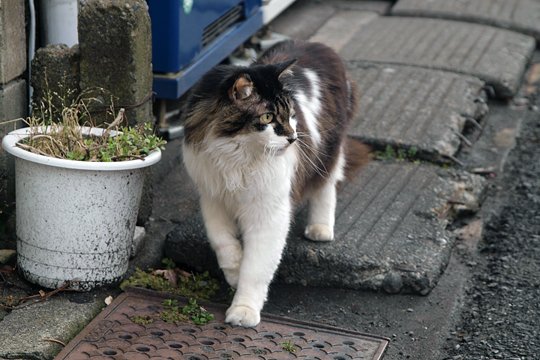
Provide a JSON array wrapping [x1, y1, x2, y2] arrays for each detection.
[[2, 91, 165, 290]]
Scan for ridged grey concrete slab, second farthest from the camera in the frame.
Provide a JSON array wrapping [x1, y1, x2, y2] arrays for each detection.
[[340, 17, 536, 98]]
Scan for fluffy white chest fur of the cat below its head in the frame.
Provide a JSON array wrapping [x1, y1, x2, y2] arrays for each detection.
[[184, 136, 298, 211]]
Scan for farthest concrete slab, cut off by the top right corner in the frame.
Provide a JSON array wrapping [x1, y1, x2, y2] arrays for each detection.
[[391, 0, 540, 41]]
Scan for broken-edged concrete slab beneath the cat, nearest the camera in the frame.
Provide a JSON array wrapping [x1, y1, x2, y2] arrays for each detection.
[[165, 162, 483, 294]]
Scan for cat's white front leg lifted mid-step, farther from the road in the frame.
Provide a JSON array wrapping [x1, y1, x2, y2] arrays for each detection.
[[201, 195, 243, 289]]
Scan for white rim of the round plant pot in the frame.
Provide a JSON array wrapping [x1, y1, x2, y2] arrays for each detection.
[[2, 126, 161, 171]]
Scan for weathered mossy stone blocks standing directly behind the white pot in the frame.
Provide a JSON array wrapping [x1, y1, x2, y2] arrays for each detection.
[[32, 0, 152, 125]]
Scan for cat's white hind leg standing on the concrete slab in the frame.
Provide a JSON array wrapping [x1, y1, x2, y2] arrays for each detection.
[[304, 146, 345, 241]]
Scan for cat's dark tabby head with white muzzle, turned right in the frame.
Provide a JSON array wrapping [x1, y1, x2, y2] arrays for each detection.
[[184, 60, 297, 155]]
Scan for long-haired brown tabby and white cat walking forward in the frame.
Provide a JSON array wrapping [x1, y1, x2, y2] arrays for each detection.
[[182, 40, 369, 327]]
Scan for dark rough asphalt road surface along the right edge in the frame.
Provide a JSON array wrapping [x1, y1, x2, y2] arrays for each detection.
[[445, 97, 540, 360]]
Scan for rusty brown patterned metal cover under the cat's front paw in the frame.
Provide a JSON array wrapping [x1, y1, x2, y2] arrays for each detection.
[[56, 290, 388, 360]]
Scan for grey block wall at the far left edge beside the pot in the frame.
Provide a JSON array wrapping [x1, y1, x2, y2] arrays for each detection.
[[0, 0, 28, 243]]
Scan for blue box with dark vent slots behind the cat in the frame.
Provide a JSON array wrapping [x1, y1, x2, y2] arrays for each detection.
[[148, 0, 262, 99]]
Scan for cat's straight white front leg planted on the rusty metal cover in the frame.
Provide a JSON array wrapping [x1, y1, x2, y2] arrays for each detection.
[[225, 204, 291, 327]]
